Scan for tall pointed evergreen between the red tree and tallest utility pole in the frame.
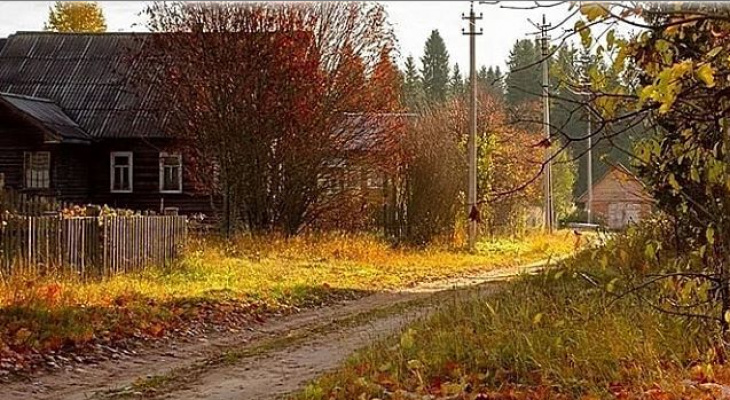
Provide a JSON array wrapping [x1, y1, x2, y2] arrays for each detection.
[[421, 30, 449, 103]]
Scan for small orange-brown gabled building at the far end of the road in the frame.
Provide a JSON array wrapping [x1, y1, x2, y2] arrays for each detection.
[[577, 164, 654, 229]]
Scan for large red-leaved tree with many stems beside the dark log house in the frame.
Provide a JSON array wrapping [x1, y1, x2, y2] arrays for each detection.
[[139, 2, 397, 234]]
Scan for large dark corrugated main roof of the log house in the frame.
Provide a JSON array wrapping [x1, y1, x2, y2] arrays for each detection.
[[0, 32, 164, 138]]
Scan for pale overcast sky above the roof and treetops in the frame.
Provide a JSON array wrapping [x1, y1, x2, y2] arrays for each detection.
[[0, 1, 567, 71]]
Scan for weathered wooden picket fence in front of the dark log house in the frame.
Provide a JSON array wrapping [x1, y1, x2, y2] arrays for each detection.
[[0, 215, 188, 278]]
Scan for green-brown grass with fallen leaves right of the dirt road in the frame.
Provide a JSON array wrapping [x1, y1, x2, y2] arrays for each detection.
[[294, 233, 716, 400]]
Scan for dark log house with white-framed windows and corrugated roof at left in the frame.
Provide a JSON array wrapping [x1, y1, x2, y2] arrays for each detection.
[[0, 32, 212, 213]]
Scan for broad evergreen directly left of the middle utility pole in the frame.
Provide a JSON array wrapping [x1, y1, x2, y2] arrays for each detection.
[[505, 39, 542, 106]]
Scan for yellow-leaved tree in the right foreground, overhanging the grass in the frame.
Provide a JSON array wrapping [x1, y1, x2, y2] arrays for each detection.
[[536, 2, 730, 346]]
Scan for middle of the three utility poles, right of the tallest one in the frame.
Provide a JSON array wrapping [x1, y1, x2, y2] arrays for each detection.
[[540, 14, 555, 233]]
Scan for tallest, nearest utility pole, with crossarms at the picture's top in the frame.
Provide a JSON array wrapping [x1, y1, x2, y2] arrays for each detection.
[[461, 1, 482, 250]]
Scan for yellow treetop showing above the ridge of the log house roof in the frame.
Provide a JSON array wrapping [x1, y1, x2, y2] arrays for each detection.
[[44, 1, 106, 32]]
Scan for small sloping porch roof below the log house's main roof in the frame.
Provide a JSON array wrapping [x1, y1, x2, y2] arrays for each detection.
[[0, 93, 91, 141]]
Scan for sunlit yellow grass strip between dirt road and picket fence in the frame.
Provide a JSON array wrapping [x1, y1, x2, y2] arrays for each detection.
[[0, 232, 574, 370]]
